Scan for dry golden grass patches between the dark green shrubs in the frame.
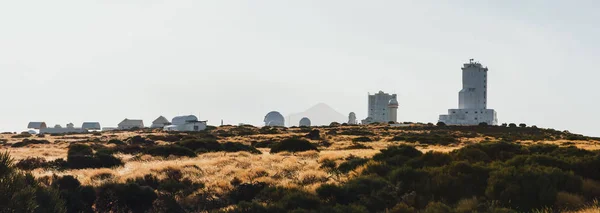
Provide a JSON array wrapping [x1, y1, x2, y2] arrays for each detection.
[[0, 126, 600, 201]]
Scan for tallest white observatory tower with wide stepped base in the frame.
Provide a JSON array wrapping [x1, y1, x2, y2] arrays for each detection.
[[439, 59, 498, 125]]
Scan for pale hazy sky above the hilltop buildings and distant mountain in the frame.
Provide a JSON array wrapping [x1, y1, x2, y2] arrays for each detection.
[[0, 0, 600, 136]]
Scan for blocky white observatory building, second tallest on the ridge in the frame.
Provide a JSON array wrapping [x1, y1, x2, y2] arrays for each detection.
[[362, 91, 398, 124]]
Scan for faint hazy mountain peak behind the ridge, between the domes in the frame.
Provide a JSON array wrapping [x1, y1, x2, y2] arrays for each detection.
[[286, 103, 350, 126]]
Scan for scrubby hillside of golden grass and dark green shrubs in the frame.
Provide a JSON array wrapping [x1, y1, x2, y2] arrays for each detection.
[[0, 124, 600, 213]]
